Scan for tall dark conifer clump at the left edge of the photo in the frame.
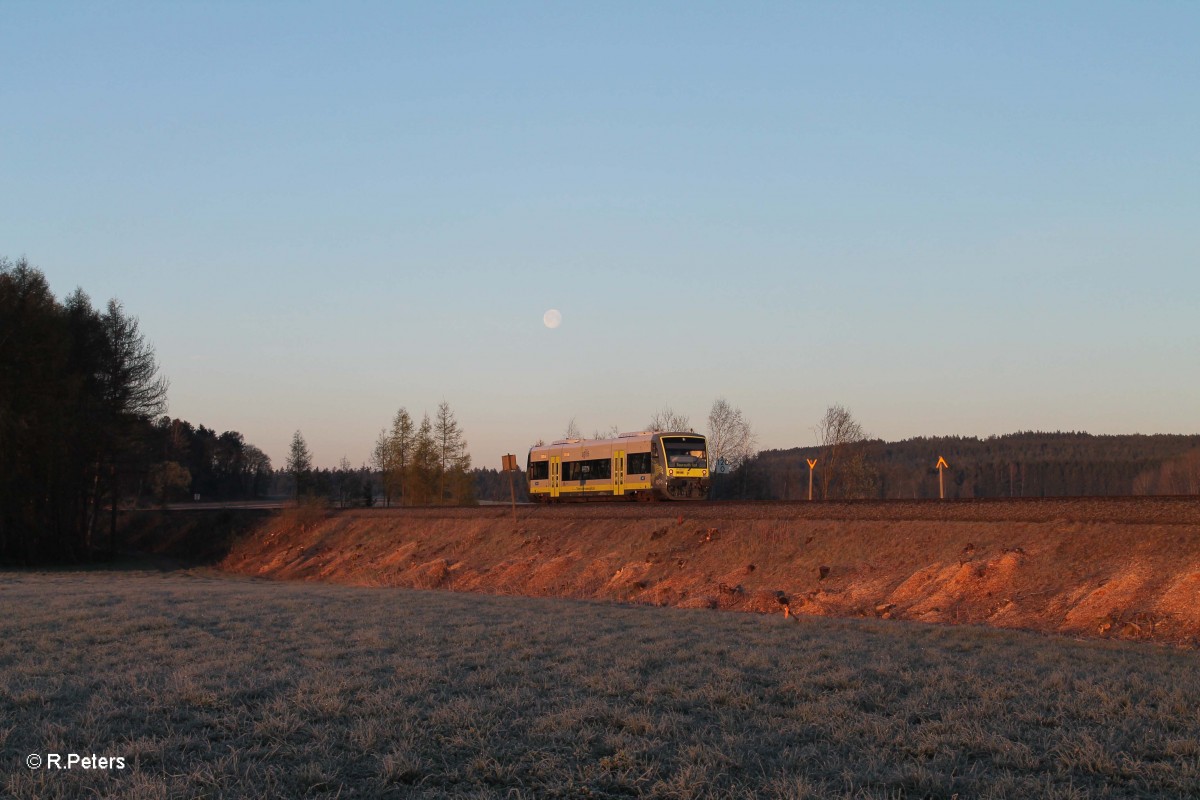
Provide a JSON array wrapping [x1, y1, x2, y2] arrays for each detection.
[[0, 259, 167, 564]]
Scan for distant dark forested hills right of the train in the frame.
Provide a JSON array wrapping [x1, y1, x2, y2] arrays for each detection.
[[714, 432, 1200, 500]]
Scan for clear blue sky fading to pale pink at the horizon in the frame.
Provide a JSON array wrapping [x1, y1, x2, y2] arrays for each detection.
[[0, 1, 1200, 468]]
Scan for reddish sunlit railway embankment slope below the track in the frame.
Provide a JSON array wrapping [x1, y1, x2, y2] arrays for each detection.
[[222, 498, 1200, 645]]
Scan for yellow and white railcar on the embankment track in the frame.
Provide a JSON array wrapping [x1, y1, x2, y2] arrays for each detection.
[[526, 431, 709, 503]]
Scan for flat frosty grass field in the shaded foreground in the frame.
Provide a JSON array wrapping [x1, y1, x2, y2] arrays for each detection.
[[7, 566, 1200, 800]]
